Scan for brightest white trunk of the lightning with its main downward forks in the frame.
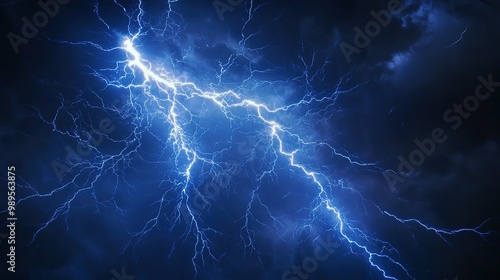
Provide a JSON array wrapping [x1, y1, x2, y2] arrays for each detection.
[[115, 35, 490, 279]]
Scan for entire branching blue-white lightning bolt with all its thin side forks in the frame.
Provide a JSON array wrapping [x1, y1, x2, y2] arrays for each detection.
[[19, 1, 491, 279]]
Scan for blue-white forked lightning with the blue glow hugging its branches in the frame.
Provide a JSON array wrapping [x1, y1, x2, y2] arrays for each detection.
[[20, 1, 490, 279]]
